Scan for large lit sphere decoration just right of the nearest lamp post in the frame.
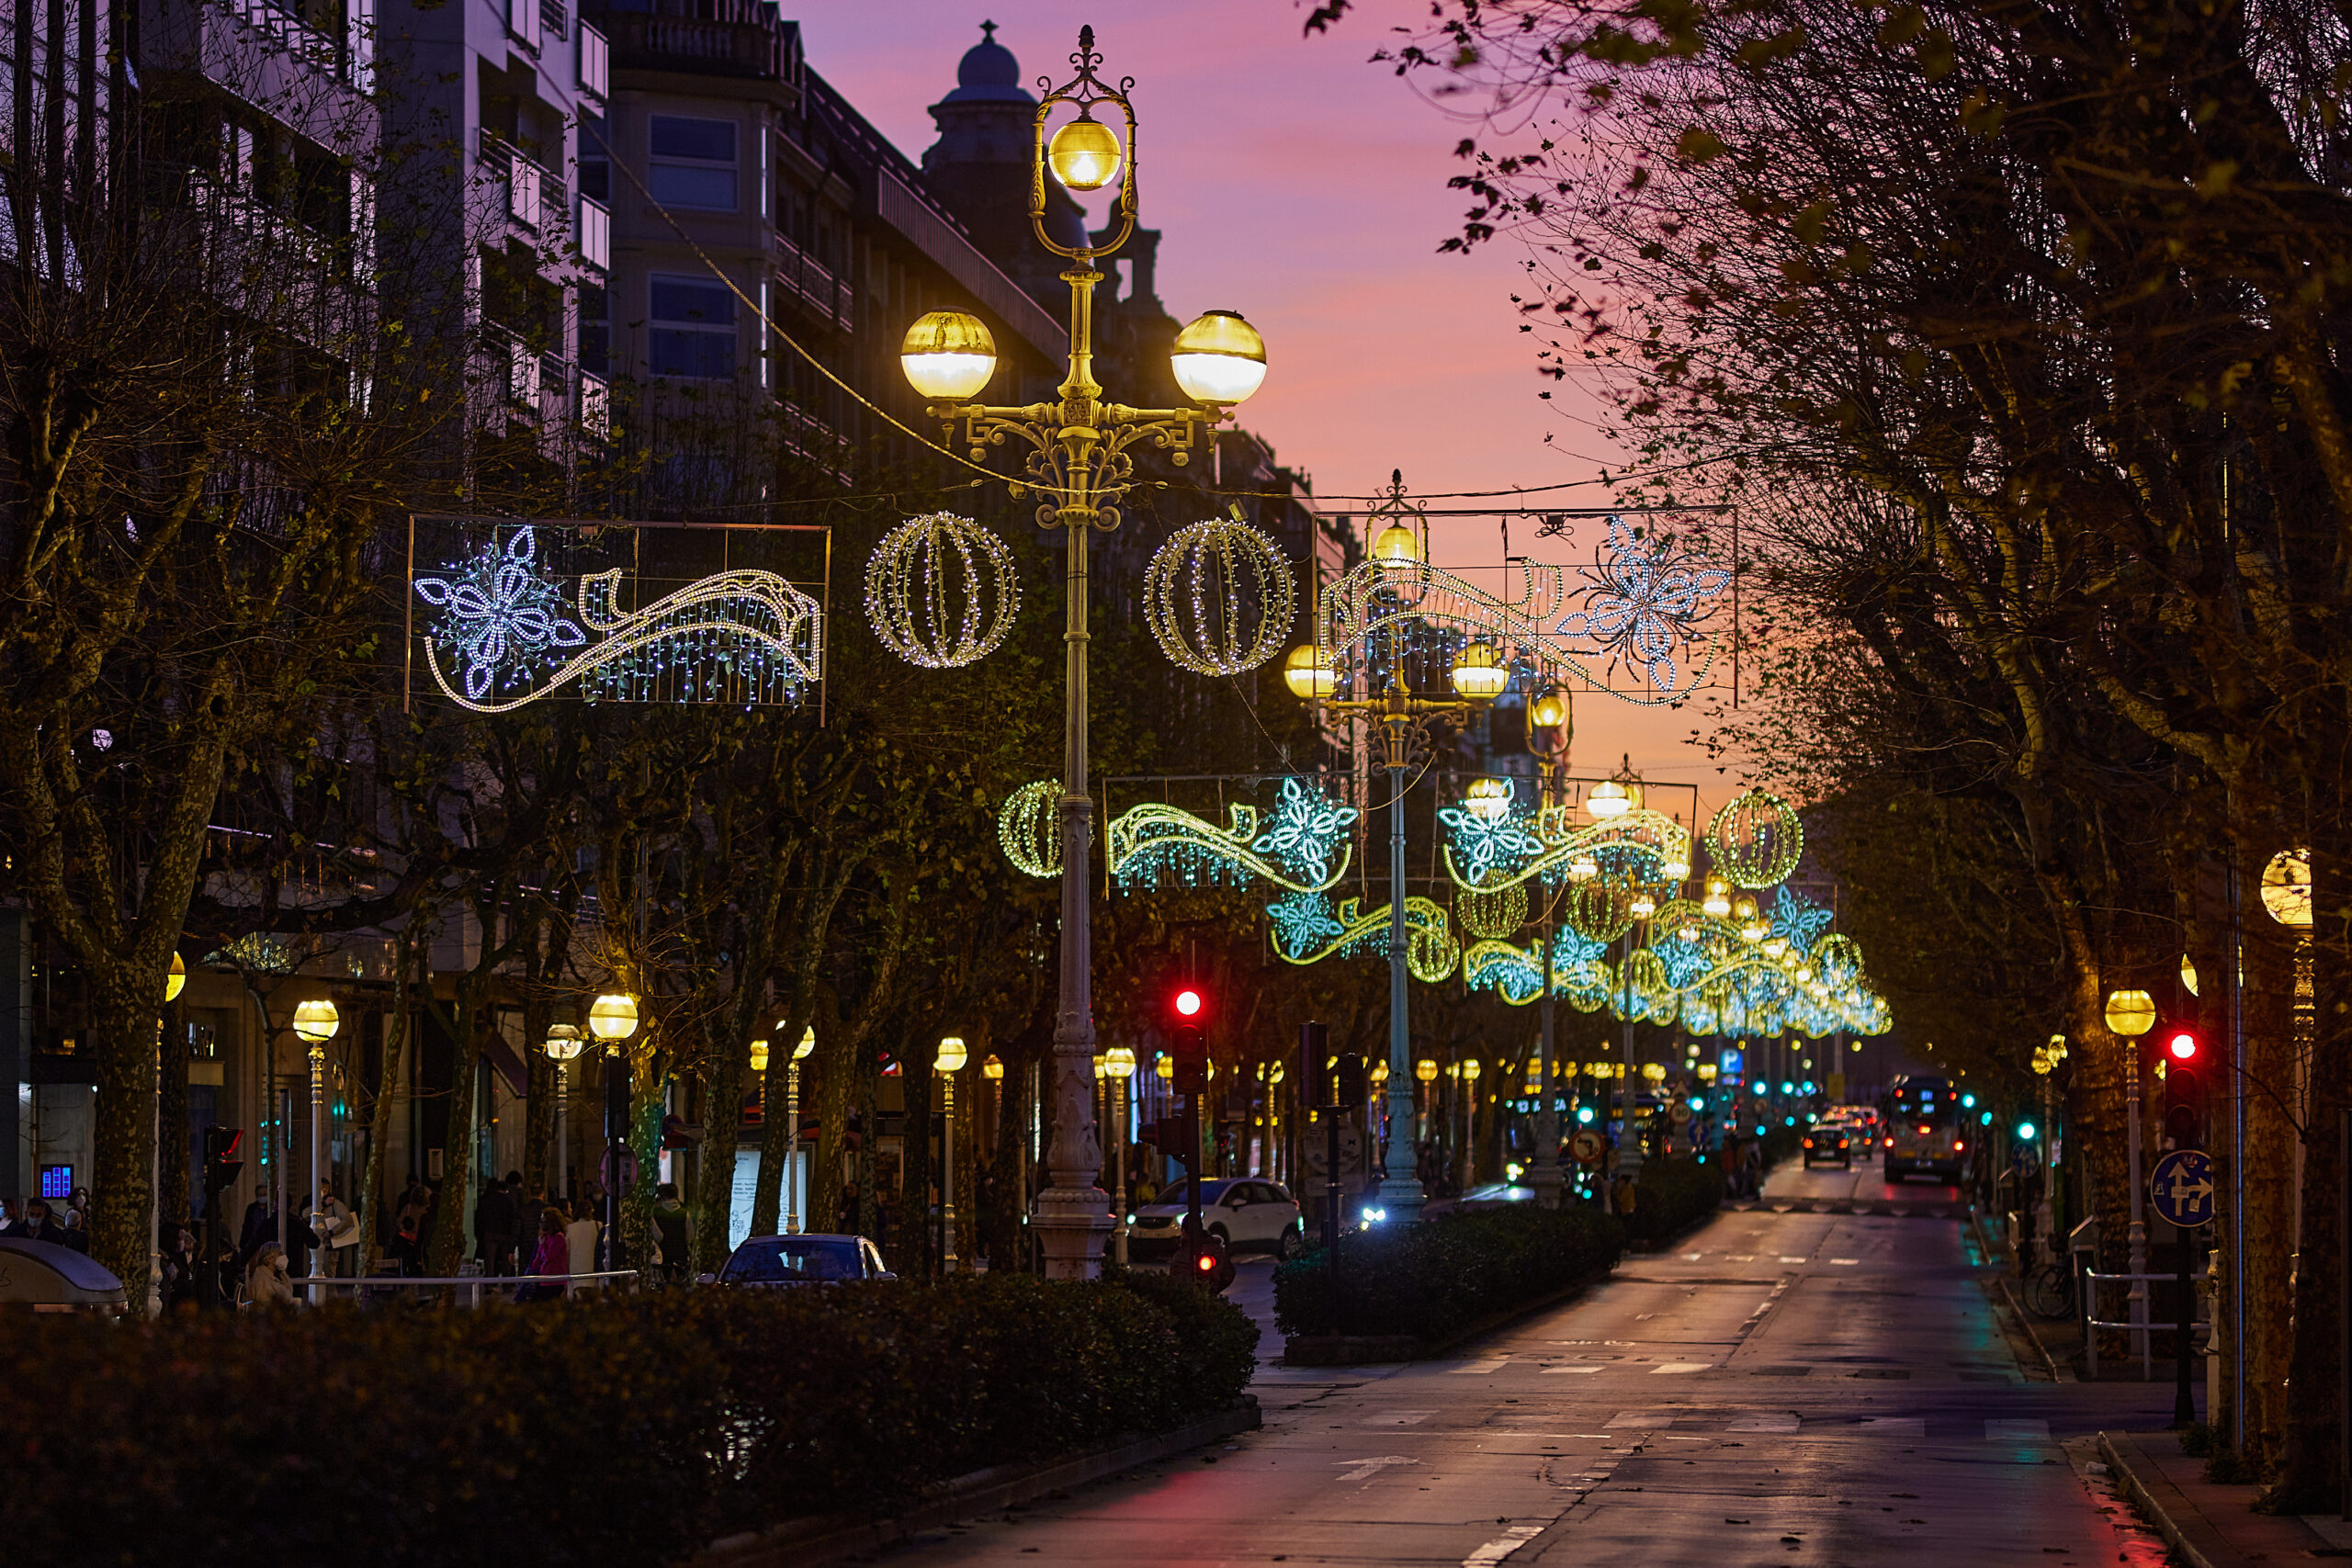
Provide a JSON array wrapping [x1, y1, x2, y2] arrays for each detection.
[[1143, 517, 1298, 674]]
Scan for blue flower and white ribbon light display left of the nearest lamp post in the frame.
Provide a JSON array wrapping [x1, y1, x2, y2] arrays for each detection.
[[414, 526, 826, 712]]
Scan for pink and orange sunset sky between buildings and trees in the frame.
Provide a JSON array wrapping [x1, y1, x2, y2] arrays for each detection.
[[799, 0, 1736, 808]]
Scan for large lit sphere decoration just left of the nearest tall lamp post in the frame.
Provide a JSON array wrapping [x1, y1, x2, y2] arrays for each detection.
[[865, 513, 1021, 670]]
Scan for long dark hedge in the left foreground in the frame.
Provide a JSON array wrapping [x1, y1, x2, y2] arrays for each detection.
[[0, 1277, 1256, 1568]]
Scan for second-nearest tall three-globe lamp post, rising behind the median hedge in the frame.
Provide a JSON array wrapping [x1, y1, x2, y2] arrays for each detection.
[[1282, 491, 1510, 1223]]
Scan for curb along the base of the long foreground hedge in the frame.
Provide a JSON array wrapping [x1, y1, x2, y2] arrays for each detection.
[[689, 1394, 1261, 1568]]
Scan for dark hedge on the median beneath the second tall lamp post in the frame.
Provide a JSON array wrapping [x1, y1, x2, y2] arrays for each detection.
[[1275, 1206, 1625, 1340]]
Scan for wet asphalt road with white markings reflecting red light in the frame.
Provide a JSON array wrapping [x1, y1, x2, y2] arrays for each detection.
[[891, 1164, 2171, 1568]]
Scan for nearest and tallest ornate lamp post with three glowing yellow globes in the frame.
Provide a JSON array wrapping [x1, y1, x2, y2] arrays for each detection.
[[899, 28, 1265, 1279]]
